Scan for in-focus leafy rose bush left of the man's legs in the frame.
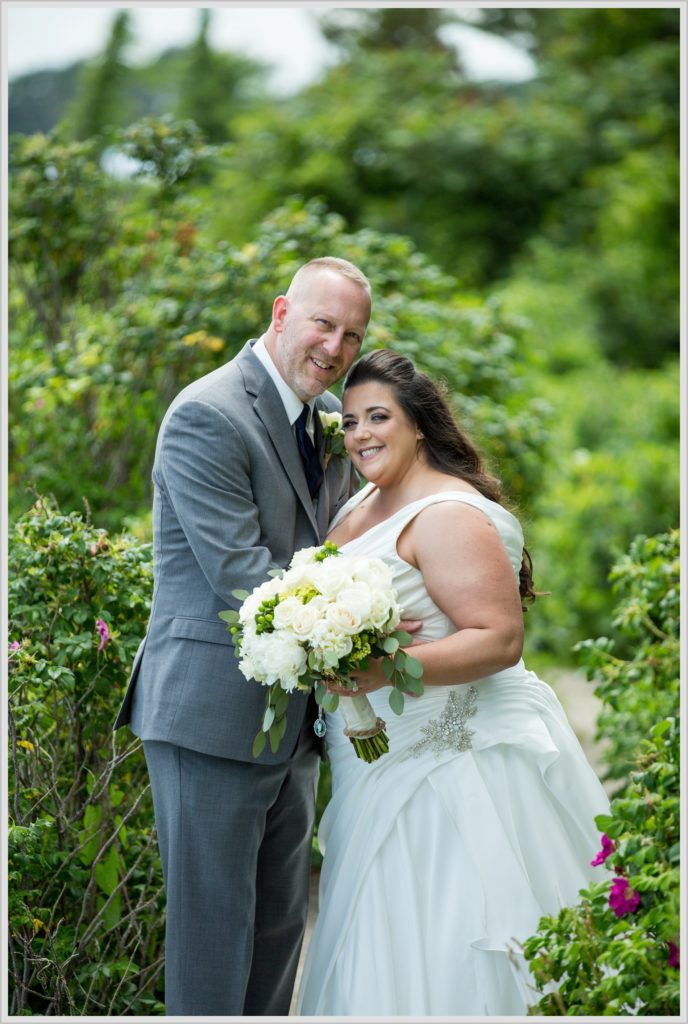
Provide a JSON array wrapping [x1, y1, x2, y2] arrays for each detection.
[[8, 499, 163, 1016]]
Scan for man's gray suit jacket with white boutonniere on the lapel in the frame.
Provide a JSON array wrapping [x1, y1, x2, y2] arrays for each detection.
[[115, 342, 356, 764]]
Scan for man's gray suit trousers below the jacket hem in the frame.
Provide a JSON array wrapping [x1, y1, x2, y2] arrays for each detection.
[[143, 724, 319, 1017]]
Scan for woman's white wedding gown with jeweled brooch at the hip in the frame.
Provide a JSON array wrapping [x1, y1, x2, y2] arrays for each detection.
[[297, 484, 609, 1019]]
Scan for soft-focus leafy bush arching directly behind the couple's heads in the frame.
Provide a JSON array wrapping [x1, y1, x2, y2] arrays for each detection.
[[9, 119, 546, 528]]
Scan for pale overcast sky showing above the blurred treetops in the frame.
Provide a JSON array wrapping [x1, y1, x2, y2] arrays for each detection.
[[3, 2, 532, 92]]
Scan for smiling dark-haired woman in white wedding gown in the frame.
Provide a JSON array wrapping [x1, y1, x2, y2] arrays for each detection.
[[298, 350, 608, 1018]]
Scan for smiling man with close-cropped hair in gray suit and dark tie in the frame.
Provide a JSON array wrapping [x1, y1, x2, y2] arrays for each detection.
[[115, 257, 371, 1017]]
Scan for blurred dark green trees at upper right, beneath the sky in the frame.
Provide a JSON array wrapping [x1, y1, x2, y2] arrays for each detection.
[[206, 8, 679, 367]]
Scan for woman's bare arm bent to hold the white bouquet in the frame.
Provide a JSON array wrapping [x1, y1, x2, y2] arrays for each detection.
[[355, 502, 523, 690]]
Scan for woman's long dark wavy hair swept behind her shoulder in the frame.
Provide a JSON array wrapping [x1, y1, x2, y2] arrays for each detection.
[[344, 348, 536, 610]]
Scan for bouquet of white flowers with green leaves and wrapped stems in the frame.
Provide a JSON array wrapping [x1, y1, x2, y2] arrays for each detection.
[[220, 542, 423, 762]]
